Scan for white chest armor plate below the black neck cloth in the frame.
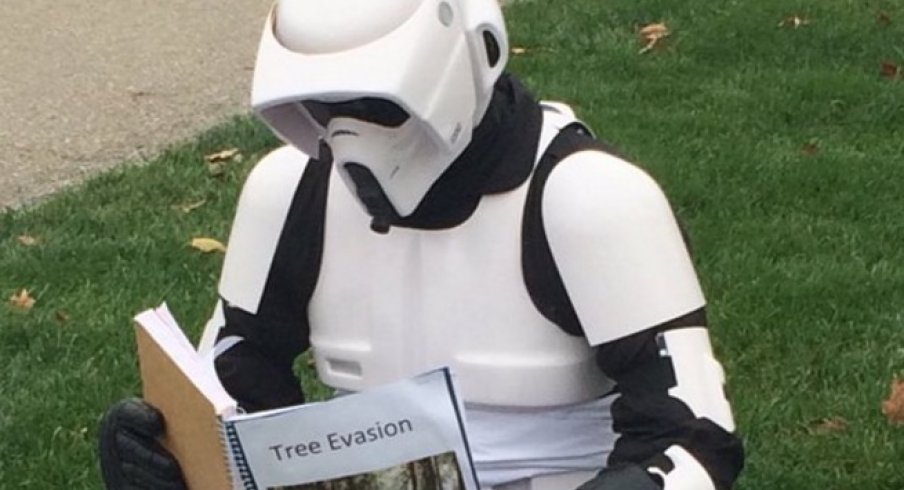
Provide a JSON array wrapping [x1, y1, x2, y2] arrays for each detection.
[[308, 111, 611, 406]]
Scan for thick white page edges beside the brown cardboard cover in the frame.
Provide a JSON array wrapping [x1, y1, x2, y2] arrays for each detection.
[[135, 303, 237, 415]]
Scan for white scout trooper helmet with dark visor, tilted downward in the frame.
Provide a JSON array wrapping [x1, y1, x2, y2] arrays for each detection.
[[251, 0, 508, 228]]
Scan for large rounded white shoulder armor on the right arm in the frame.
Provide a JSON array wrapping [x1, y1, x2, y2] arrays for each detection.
[[542, 150, 705, 345]]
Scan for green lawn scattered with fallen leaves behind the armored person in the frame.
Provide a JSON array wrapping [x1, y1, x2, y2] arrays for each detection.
[[0, 0, 904, 490]]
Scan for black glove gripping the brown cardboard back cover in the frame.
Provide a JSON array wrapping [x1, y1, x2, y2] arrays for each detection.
[[98, 398, 188, 490]]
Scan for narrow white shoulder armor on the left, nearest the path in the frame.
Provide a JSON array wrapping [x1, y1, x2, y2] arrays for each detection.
[[219, 146, 309, 313]]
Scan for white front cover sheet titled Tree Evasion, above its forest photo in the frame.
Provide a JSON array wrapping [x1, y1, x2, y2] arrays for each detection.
[[227, 369, 478, 490]]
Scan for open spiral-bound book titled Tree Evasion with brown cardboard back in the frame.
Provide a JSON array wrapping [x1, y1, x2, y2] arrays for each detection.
[[135, 305, 478, 490]]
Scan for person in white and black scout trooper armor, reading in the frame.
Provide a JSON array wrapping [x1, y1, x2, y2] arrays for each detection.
[[100, 0, 743, 490]]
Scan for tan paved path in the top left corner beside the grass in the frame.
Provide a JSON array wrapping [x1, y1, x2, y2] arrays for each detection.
[[0, 0, 271, 209]]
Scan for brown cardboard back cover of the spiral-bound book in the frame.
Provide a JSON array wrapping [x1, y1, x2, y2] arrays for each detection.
[[135, 326, 232, 490]]
